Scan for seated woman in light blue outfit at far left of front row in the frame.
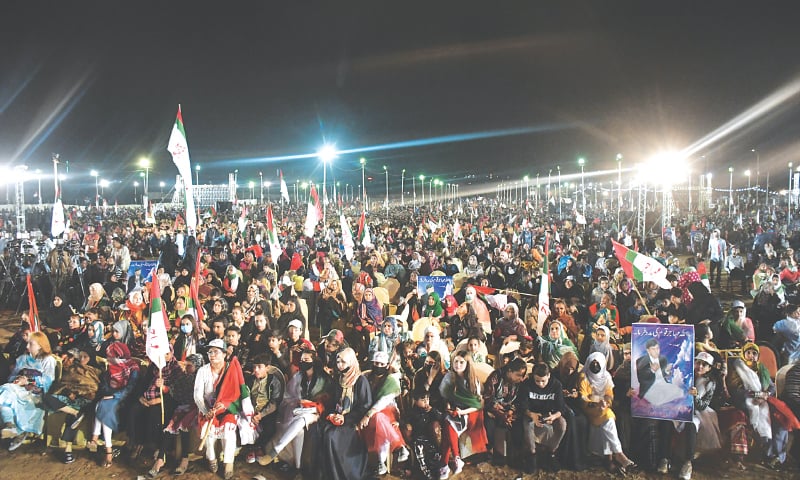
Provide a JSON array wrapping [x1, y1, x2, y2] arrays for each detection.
[[0, 332, 56, 451]]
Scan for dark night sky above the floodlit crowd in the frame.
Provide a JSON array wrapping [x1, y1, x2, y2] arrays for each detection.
[[0, 0, 800, 201]]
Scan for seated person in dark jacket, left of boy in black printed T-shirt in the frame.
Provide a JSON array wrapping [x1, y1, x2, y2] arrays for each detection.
[[483, 358, 528, 465]]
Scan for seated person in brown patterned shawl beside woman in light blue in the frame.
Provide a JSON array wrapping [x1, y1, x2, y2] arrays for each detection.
[[42, 349, 101, 464]]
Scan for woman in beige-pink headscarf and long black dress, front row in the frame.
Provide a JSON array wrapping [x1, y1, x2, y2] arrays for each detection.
[[317, 348, 372, 480]]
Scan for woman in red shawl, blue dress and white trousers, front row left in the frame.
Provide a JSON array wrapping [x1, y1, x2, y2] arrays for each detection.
[[86, 341, 139, 468]]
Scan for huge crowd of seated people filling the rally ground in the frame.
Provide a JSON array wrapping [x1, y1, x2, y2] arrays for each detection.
[[0, 202, 800, 480]]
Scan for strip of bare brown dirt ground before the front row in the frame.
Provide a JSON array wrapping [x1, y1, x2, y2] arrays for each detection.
[[0, 274, 800, 480]]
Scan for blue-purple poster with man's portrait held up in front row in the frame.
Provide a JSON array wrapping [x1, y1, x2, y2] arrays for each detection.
[[631, 323, 694, 422]]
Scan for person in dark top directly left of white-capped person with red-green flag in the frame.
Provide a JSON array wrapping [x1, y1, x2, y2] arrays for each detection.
[[149, 353, 204, 477]]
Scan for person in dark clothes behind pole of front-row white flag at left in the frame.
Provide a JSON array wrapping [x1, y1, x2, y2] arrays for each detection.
[[126, 345, 181, 460]]
